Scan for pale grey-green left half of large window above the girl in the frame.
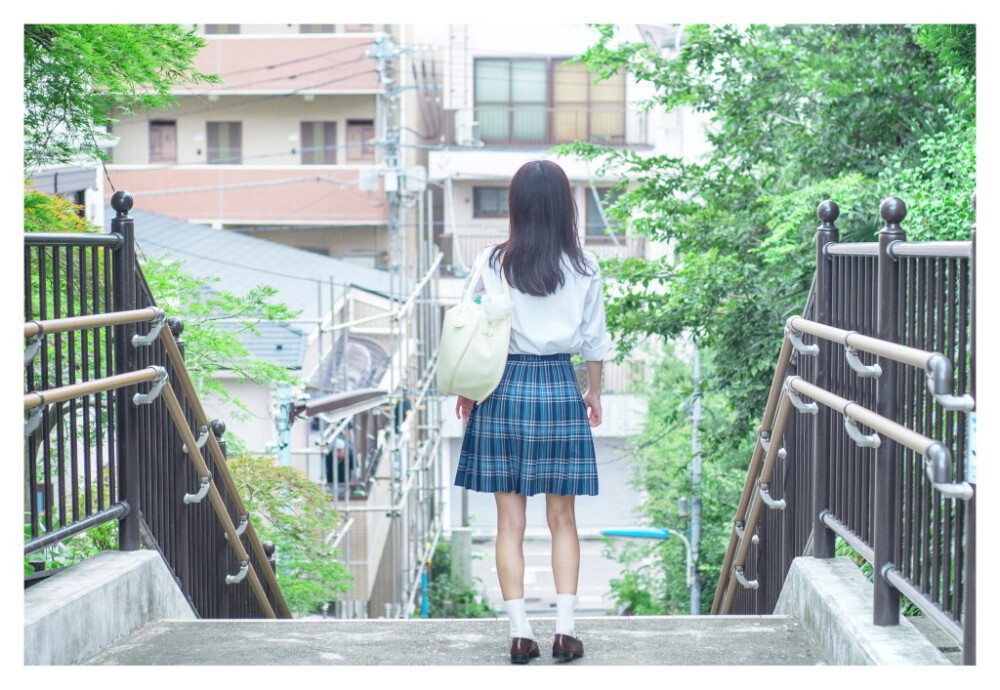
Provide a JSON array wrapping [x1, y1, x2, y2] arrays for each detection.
[[474, 58, 548, 144]]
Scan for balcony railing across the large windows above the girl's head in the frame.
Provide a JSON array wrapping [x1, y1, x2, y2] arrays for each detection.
[[449, 105, 653, 148]]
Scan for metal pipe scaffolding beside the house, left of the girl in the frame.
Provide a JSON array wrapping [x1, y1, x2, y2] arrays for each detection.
[[291, 185, 449, 618]]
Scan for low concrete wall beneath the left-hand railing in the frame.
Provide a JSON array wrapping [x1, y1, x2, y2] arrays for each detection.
[[24, 551, 196, 665]]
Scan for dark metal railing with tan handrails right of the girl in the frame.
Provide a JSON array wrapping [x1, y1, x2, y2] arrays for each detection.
[[712, 197, 976, 664]]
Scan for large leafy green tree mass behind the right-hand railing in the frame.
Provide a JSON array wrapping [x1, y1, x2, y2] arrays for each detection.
[[555, 25, 976, 608]]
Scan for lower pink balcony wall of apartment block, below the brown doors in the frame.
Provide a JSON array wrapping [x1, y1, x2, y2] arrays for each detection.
[[108, 165, 388, 226]]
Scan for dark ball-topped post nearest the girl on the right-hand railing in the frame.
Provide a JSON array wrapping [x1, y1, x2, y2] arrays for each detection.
[[812, 199, 840, 558]]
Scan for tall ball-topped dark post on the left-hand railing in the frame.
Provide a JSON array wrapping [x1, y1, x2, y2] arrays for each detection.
[[111, 190, 141, 551]]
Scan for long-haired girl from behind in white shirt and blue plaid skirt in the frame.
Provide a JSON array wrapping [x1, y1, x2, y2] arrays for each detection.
[[455, 160, 612, 664]]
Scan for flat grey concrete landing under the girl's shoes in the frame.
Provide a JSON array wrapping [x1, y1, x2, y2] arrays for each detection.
[[85, 616, 827, 666]]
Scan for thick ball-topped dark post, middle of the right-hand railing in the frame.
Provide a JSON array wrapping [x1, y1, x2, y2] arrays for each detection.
[[872, 196, 906, 625]]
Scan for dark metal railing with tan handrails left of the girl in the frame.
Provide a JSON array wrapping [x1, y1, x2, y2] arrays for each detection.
[[24, 192, 291, 618]]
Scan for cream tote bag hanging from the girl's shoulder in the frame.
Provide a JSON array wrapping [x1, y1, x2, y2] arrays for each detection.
[[437, 253, 511, 402]]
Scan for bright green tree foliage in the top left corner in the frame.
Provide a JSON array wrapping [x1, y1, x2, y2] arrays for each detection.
[[24, 24, 219, 170]]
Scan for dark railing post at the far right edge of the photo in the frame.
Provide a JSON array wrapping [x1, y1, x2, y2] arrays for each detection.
[[962, 193, 978, 666]]
